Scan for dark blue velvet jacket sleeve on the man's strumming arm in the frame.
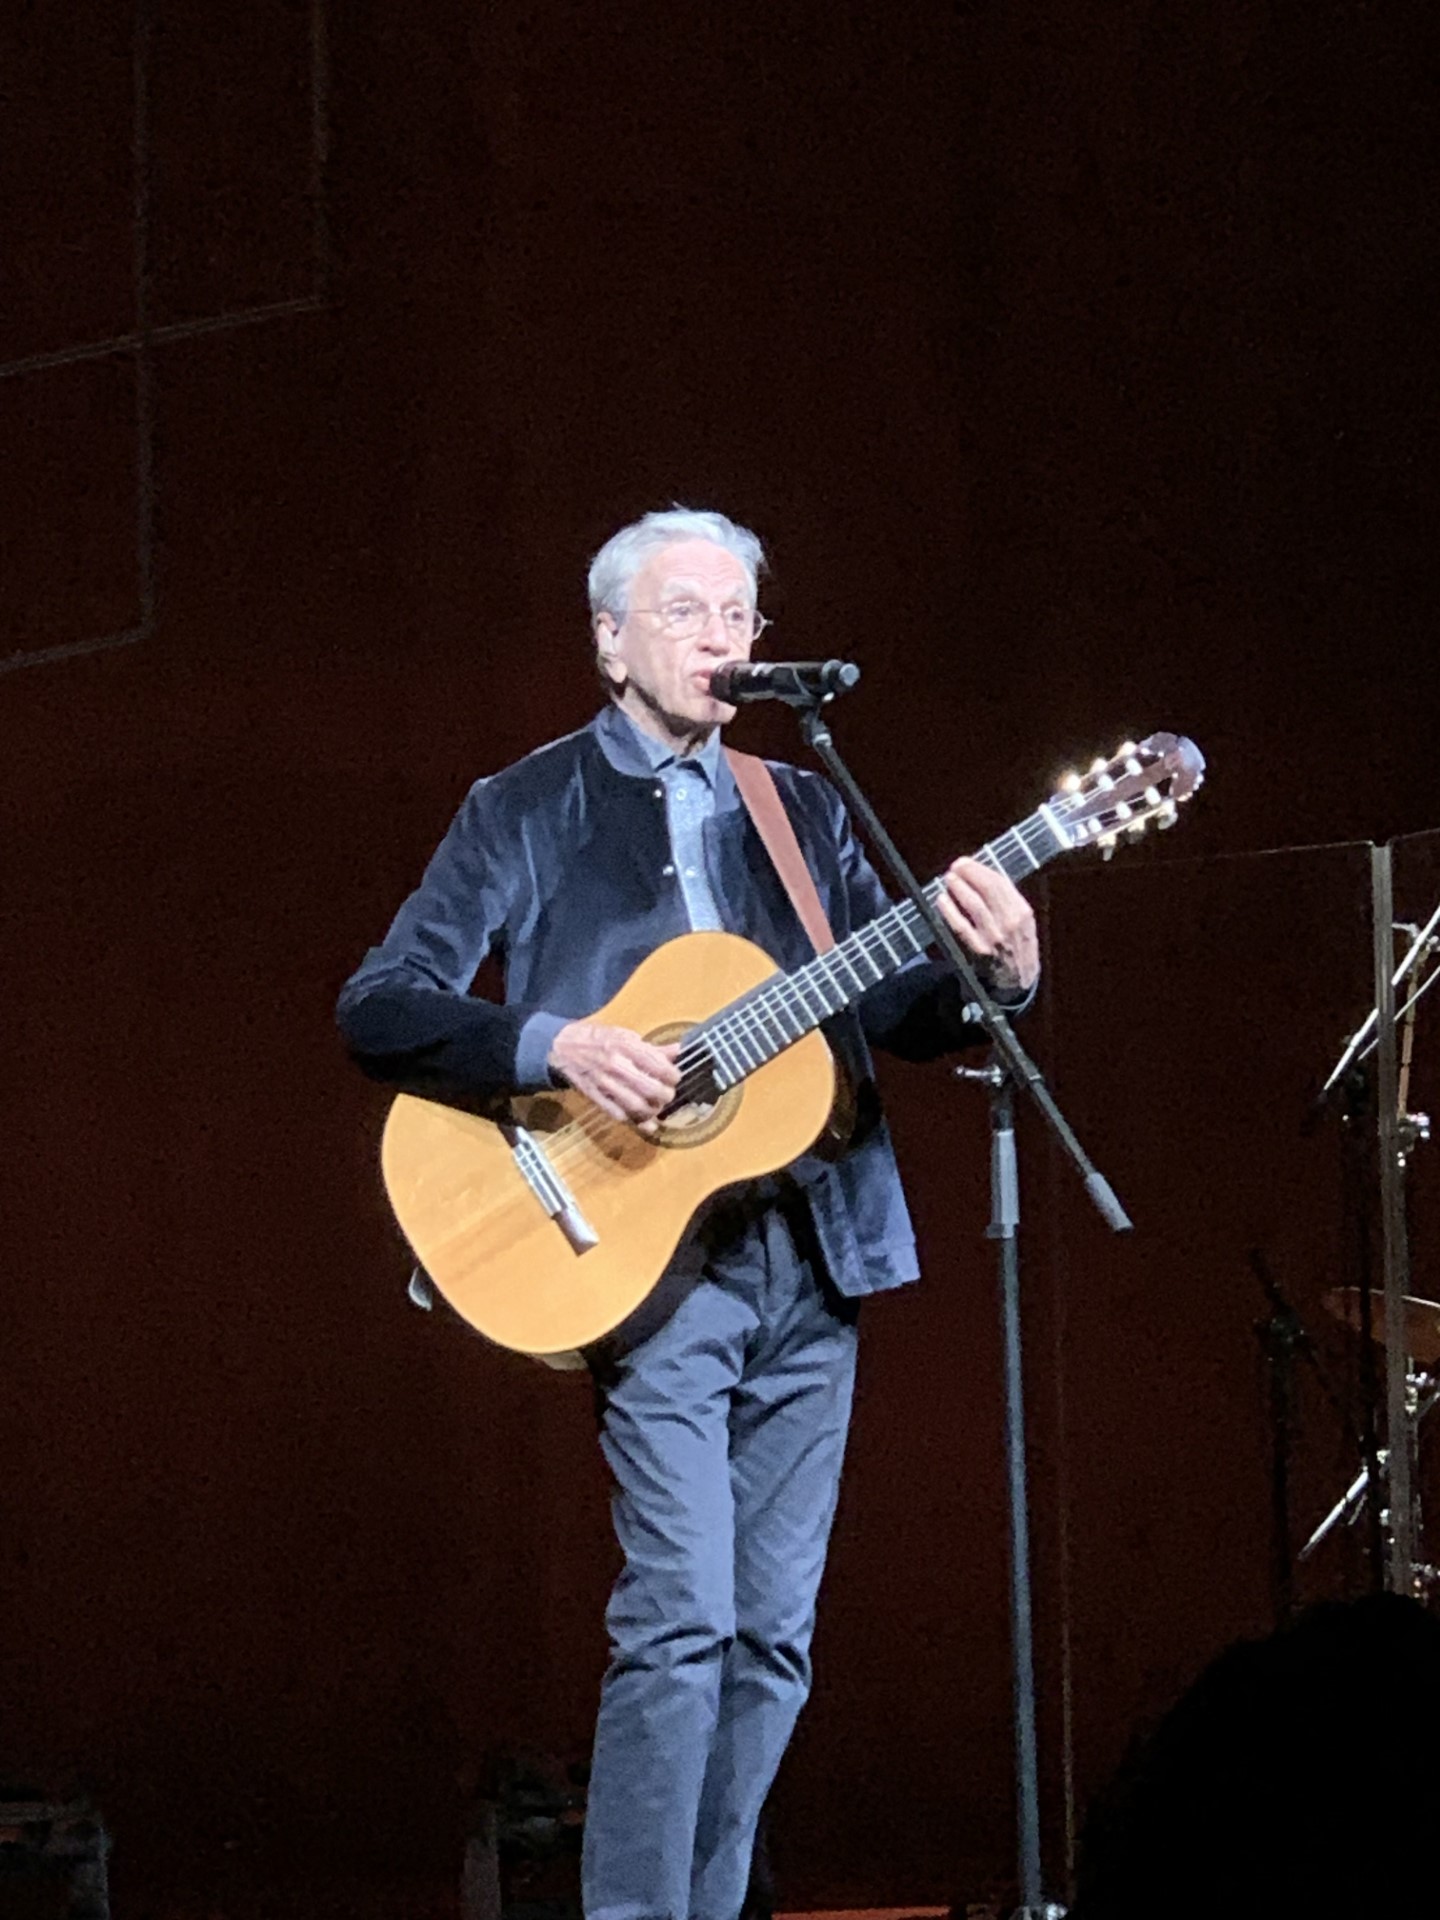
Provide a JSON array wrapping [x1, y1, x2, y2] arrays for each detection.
[[336, 780, 547, 1104]]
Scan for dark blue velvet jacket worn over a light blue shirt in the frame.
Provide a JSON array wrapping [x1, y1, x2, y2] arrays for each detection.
[[338, 724, 1006, 1294]]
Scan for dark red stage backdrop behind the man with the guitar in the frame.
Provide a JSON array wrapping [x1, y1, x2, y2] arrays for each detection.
[[0, 0, 1440, 1912]]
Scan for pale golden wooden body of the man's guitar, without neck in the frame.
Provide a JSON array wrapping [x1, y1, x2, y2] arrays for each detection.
[[382, 933, 835, 1365]]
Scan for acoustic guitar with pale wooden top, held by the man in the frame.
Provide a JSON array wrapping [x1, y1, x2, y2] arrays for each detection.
[[382, 733, 1204, 1367]]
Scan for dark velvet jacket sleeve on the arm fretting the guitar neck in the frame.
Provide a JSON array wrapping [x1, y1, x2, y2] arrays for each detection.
[[816, 781, 1035, 1060]]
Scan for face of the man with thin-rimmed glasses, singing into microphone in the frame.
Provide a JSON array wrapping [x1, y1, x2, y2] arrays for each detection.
[[595, 540, 755, 745]]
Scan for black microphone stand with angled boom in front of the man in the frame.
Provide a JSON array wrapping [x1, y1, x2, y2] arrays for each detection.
[[783, 689, 1131, 1920]]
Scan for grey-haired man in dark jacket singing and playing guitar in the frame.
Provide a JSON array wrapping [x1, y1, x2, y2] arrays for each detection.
[[340, 509, 1039, 1920]]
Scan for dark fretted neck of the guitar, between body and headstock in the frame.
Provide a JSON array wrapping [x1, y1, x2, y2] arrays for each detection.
[[687, 806, 1071, 1089]]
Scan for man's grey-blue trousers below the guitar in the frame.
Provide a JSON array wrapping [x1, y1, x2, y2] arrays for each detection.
[[584, 1200, 856, 1920]]
